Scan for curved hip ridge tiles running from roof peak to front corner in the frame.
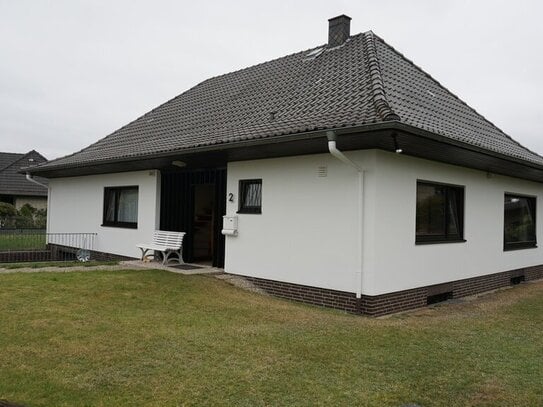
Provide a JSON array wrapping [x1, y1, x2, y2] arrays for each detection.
[[364, 31, 400, 121]]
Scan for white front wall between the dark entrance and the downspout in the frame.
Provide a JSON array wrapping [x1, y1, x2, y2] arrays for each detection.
[[225, 151, 375, 291]]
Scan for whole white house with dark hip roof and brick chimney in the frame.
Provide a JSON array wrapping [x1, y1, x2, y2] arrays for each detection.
[[25, 16, 543, 315]]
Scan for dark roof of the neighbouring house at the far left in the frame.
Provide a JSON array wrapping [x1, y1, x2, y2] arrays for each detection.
[[0, 150, 47, 196]]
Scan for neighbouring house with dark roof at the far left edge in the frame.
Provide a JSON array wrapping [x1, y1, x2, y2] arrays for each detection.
[[0, 150, 47, 209]]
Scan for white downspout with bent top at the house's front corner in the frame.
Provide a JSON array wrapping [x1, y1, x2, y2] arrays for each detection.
[[326, 131, 364, 298]]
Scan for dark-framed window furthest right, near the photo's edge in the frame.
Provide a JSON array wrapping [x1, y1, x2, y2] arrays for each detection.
[[503, 194, 537, 250]]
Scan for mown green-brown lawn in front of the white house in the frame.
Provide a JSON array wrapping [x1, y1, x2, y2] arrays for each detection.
[[0, 270, 543, 406]]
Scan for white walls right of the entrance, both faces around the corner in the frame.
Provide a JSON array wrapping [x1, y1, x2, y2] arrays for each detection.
[[225, 150, 543, 295]]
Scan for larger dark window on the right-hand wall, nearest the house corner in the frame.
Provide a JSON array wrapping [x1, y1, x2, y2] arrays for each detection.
[[415, 181, 464, 243]]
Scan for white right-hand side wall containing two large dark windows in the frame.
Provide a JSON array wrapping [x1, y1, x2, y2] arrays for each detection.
[[370, 151, 543, 295]]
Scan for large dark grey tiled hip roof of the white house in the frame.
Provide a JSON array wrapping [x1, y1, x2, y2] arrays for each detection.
[[33, 32, 543, 169]]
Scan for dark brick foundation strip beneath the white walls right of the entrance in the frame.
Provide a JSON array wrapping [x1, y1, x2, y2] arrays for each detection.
[[236, 265, 543, 316]]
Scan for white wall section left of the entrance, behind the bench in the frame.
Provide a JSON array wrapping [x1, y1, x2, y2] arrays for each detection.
[[47, 170, 160, 257]]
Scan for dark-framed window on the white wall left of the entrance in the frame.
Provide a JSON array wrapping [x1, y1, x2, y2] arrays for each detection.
[[102, 186, 138, 229]]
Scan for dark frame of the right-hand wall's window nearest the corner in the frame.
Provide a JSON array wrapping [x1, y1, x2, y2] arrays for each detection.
[[415, 180, 466, 245]]
